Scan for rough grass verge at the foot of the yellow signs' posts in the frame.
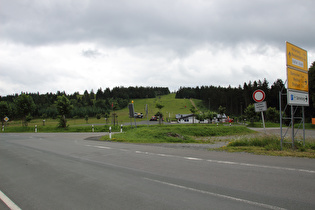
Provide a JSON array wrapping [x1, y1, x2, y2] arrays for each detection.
[[211, 135, 315, 158]]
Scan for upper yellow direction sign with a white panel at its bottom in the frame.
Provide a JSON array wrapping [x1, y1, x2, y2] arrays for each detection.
[[286, 42, 308, 71]]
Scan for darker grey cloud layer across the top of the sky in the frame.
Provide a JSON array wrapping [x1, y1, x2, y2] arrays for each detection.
[[1, 0, 315, 52]]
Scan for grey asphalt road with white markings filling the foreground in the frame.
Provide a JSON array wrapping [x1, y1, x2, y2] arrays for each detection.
[[0, 133, 315, 210]]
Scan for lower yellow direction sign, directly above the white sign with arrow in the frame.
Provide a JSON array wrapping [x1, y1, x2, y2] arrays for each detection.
[[287, 67, 308, 92]]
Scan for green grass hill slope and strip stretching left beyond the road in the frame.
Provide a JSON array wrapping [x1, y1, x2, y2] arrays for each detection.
[[1, 93, 201, 132]]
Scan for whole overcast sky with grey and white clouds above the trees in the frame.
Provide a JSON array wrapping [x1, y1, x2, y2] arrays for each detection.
[[0, 0, 315, 96]]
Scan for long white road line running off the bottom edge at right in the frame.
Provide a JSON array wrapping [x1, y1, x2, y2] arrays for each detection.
[[144, 178, 286, 210]]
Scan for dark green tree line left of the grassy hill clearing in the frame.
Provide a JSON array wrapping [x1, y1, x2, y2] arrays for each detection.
[[0, 87, 170, 125]]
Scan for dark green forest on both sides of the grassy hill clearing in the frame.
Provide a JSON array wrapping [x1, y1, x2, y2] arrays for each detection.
[[0, 62, 315, 122]]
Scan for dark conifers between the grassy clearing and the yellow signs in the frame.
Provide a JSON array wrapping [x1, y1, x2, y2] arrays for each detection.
[[175, 79, 285, 116]]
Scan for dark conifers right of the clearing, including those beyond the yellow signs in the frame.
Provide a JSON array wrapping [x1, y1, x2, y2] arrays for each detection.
[[176, 62, 315, 122]]
